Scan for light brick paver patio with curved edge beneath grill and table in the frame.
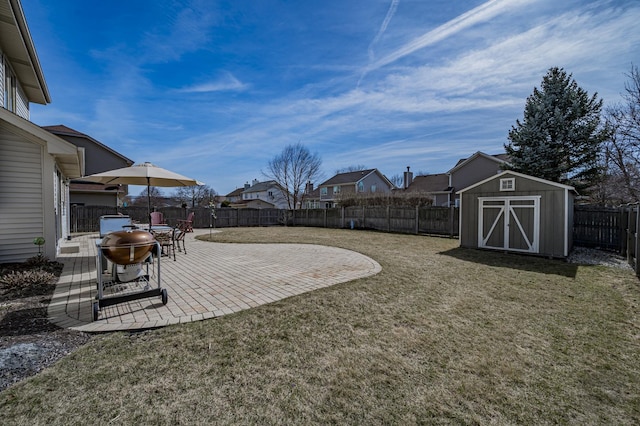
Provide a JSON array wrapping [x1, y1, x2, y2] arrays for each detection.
[[49, 229, 381, 332]]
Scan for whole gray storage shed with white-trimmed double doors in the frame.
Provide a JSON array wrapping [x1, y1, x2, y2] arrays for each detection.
[[458, 171, 576, 257]]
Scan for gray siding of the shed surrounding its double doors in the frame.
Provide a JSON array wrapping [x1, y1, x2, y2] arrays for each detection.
[[460, 174, 573, 257]]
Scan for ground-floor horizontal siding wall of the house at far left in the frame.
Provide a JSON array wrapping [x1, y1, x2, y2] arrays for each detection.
[[0, 129, 44, 263]]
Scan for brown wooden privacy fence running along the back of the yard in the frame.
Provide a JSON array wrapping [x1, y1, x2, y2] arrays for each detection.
[[71, 204, 640, 276]]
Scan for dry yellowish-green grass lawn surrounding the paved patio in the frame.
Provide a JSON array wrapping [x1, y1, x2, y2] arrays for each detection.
[[0, 228, 640, 425]]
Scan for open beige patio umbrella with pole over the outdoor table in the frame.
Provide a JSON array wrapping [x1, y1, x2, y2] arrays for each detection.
[[80, 163, 203, 225]]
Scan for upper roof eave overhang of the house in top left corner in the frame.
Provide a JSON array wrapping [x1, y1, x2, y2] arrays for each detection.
[[0, 0, 51, 105]]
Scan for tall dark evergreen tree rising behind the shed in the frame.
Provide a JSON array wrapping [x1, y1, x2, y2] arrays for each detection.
[[505, 67, 607, 191]]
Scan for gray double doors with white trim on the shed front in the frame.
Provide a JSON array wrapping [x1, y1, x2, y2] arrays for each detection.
[[478, 196, 540, 253]]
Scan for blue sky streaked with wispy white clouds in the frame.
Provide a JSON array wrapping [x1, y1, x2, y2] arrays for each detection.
[[22, 0, 640, 194]]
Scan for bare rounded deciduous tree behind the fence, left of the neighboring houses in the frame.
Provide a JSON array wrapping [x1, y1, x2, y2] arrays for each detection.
[[263, 142, 322, 210]]
